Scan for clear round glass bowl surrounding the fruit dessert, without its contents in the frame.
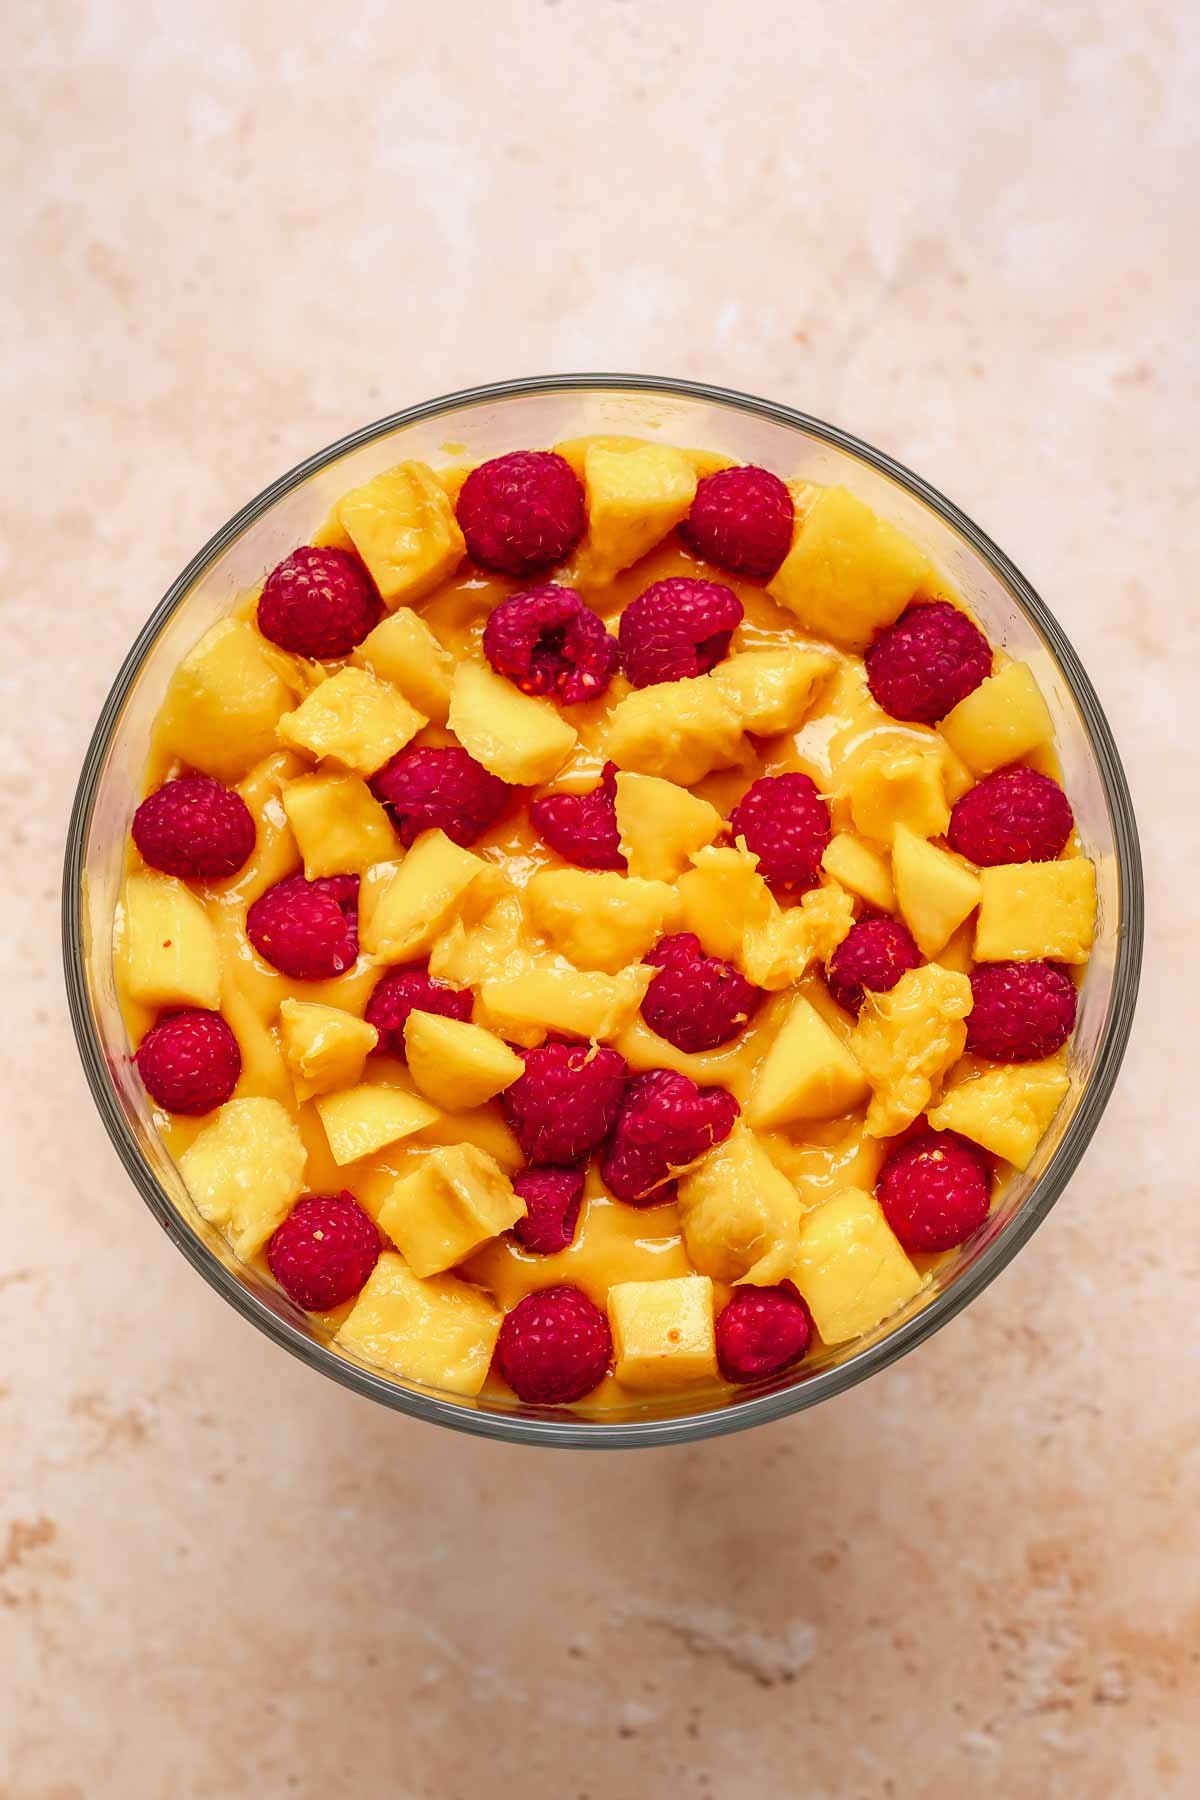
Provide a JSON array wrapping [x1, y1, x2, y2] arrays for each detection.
[[63, 374, 1142, 1449]]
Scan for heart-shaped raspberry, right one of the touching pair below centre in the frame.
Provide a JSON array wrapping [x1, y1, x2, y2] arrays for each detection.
[[600, 1069, 739, 1206]]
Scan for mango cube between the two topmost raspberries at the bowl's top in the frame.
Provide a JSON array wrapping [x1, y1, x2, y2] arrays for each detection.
[[583, 443, 696, 581]]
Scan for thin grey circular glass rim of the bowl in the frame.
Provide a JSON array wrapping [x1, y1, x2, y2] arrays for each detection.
[[61, 373, 1144, 1449]]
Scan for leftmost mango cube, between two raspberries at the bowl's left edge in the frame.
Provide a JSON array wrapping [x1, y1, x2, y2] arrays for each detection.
[[117, 871, 221, 1012]]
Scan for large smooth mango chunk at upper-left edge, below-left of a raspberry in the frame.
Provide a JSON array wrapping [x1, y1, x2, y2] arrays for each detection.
[[160, 619, 295, 781]]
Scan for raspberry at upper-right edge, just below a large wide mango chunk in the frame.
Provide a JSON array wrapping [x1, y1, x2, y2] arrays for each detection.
[[864, 599, 991, 725]]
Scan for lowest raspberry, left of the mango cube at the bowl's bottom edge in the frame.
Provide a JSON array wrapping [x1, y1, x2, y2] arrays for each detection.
[[497, 1287, 612, 1406]]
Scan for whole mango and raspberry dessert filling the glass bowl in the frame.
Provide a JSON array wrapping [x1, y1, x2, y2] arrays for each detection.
[[115, 437, 1096, 1409]]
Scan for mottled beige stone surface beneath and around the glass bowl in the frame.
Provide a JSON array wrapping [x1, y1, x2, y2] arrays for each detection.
[[0, 0, 1200, 1800]]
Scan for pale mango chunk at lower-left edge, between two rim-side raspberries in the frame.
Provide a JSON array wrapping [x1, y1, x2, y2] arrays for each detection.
[[180, 1100, 308, 1258]]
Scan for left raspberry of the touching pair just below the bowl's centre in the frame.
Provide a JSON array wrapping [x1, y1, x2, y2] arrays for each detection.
[[504, 1044, 628, 1165]]
